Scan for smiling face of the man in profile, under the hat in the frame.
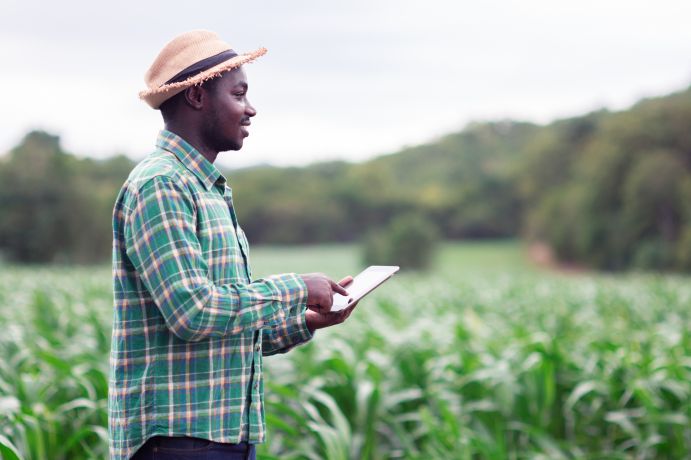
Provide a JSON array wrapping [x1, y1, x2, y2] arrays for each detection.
[[203, 67, 257, 152]]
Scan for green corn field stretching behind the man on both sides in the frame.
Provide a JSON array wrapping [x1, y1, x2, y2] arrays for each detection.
[[0, 243, 691, 460]]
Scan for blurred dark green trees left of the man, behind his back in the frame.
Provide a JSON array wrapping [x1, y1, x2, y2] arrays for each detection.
[[0, 131, 133, 263]]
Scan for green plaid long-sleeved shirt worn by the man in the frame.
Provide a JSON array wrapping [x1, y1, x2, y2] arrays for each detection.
[[108, 131, 311, 459]]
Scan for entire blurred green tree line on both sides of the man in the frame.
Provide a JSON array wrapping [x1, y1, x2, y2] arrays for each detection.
[[0, 89, 691, 270]]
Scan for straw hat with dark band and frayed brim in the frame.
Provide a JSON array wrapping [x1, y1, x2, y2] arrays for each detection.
[[139, 30, 266, 109]]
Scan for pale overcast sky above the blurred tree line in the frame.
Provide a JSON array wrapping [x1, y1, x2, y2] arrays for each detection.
[[0, 0, 691, 167]]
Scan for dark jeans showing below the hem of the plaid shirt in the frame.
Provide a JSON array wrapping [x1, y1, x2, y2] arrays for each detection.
[[131, 436, 257, 460]]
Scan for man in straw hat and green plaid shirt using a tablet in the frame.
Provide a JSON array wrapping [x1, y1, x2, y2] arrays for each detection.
[[109, 31, 355, 459]]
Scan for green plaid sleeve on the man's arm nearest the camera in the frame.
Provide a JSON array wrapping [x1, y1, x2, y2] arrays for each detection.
[[124, 177, 307, 341]]
